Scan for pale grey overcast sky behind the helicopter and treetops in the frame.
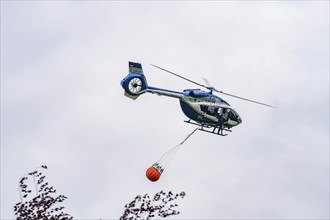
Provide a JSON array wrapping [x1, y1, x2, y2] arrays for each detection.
[[0, 1, 330, 219]]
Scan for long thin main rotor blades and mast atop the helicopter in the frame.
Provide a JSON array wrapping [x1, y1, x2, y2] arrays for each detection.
[[150, 64, 276, 108]]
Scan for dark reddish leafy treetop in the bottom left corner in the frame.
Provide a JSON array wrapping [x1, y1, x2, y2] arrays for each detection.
[[14, 166, 73, 220]]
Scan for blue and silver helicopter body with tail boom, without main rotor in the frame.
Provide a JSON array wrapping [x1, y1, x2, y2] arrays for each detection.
[[121, 69, 242, 133]]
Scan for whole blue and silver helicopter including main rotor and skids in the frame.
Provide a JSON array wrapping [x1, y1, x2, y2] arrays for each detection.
[[120, 61, 275, 136]]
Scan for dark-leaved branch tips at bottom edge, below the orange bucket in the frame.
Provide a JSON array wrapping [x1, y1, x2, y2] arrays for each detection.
[[120, 191, 186, 220]]
